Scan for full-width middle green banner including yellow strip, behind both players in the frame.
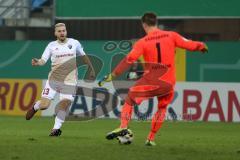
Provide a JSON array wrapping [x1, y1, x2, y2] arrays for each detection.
[[0, 41, 240, 82]]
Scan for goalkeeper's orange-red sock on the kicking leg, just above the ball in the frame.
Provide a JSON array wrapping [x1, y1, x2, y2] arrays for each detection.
[[120, 102, 133, 128]]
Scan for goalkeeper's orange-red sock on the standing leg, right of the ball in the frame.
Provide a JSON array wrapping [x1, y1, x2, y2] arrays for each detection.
[[148, 107, 167, 141]]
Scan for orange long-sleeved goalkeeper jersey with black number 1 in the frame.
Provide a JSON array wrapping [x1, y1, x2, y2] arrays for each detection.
[[113, 29, 204, 85]]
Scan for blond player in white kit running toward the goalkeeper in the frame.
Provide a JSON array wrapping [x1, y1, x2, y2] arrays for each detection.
[[26, 23, 95, 136]]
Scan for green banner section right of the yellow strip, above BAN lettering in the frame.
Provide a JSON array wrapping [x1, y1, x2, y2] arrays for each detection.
[[186, 42, 240, 82]]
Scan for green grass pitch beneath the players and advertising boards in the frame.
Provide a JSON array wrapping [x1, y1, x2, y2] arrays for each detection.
[[0, 116, 240, 160]]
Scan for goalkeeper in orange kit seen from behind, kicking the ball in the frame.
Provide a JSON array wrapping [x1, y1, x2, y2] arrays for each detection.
[[99, 13, 208, 146]]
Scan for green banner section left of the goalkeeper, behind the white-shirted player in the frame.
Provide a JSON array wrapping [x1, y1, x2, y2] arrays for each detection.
[[0, 41, 131, 79]]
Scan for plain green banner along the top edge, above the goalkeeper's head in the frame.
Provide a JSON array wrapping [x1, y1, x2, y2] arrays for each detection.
[[56, 0, 240, 18]]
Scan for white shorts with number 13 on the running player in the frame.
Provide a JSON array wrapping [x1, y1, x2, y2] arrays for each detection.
[[42, 80, 75, 101]]
